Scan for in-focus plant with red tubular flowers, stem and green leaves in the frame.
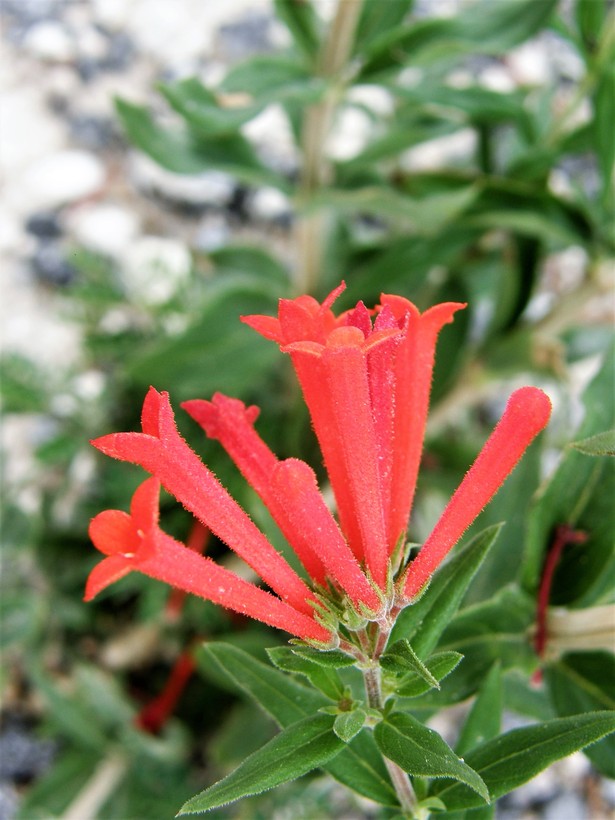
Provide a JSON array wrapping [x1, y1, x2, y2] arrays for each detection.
[[86, 284, 615, 818]]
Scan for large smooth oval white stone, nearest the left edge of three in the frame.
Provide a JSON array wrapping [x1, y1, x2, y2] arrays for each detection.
[[21, 151, 106, 210]]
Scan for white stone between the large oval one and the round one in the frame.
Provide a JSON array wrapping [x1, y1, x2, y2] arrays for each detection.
[[67, 203, 139, 258]]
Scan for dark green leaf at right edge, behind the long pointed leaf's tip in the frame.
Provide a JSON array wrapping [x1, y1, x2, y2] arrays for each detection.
[[544, 652, 615, 778]]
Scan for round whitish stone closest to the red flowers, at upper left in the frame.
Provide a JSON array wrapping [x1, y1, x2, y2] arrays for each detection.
[[124, 236, 192, 305]]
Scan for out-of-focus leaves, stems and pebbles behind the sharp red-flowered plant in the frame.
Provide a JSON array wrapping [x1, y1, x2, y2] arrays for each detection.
[[0, 0, 615, 820]]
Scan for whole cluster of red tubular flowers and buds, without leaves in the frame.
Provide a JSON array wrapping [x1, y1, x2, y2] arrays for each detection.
[[86, 284, 551, 645]]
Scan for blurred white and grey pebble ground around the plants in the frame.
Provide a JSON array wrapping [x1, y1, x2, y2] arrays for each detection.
[[0, 0, 615, 820]]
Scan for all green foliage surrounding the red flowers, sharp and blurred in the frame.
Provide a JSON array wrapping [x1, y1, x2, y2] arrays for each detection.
[[6, 0, 615, 820]]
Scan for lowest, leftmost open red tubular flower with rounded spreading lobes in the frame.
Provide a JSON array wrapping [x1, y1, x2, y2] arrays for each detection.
[[85, 478, 331, 643]]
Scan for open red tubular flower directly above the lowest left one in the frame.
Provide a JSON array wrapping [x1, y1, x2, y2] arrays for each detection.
[[92, 387, 315, 614]]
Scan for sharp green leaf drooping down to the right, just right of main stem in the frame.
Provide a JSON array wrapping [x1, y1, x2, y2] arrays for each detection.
[[374, 712, 489, 808]]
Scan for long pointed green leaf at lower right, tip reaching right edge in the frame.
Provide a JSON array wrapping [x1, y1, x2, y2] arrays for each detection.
[[432, 712, 615, 811]]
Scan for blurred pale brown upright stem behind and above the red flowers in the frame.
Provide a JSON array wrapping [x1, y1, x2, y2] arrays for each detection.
[[295, 0, 363, 293]]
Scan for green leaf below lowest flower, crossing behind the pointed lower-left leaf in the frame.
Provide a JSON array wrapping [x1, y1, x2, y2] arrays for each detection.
[[196, 643, 395, 805]]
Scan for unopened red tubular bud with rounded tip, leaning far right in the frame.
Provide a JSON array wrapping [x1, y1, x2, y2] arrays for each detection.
[[403, 387, 551, 599]]
